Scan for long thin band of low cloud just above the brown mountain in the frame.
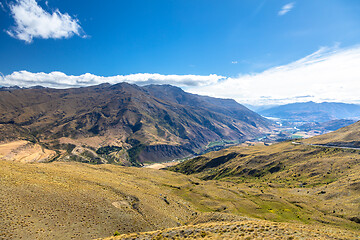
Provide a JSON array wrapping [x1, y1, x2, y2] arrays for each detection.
[[0, 71, 224, 88]]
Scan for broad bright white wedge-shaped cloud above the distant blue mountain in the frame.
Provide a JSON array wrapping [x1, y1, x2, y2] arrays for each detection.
[[190, 46, 360, 105]]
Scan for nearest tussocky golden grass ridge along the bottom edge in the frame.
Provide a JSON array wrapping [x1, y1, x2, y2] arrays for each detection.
[[101, 220, 359, 240]]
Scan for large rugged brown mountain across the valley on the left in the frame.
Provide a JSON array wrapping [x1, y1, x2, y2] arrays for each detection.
[[0, 83, 271, 165]]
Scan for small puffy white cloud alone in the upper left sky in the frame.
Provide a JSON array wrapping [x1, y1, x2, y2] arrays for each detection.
[[7, 0, 82, 43]]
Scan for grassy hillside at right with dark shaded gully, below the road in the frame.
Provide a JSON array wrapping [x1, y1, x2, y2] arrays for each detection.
[[169, 142, 360, 229]]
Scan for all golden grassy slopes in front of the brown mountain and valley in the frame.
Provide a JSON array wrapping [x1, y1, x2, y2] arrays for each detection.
[[0, 142, 360, 239]]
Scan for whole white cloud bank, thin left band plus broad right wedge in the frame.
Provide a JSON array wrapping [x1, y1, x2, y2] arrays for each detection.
[[0, 46, 360, 105]]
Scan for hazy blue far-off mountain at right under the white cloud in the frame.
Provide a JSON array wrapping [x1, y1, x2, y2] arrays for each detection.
[[258, 102, 360, 122]]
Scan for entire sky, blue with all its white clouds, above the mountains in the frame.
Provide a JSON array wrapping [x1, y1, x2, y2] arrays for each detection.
[[0, 0, 360, 105]]
